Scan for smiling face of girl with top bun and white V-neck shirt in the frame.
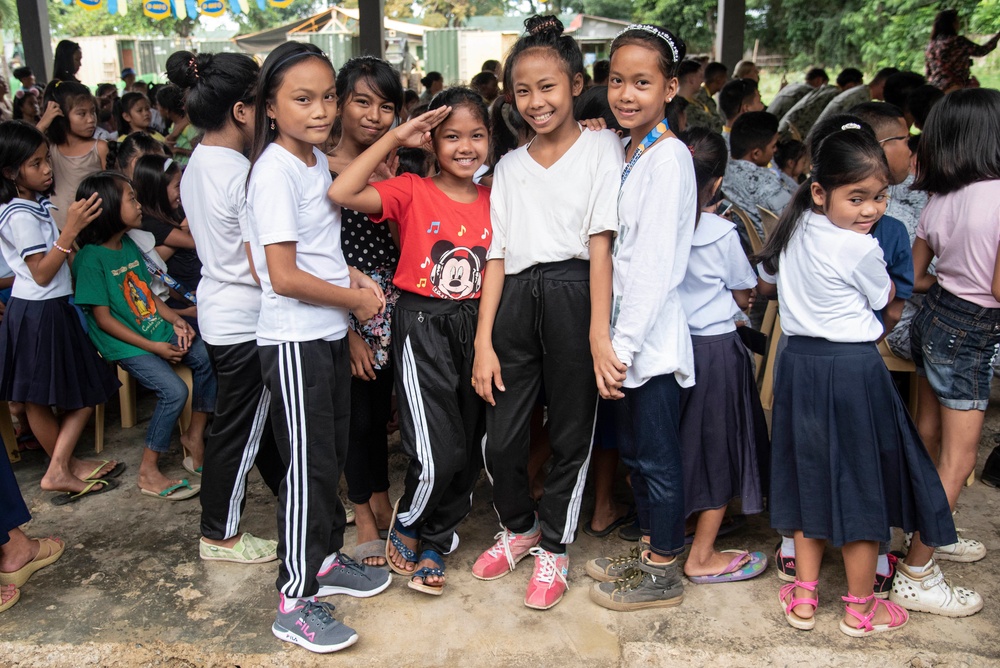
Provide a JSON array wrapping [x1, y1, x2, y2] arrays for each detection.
[[512, 47, 583, 135]]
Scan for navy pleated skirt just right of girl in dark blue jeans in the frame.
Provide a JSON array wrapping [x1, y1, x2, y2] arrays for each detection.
[[680, 331, 770, 516]]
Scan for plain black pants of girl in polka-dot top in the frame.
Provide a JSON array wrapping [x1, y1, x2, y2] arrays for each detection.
[[344, 369, 392, 503]]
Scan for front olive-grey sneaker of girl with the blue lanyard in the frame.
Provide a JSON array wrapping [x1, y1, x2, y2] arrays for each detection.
[[590, 558, 684, 612]]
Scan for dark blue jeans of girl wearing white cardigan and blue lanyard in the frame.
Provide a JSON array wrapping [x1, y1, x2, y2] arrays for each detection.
[[614, 374, 684, 557]]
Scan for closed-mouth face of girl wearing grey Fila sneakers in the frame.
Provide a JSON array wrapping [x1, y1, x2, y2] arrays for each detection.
[[267, 56, 337, 156]]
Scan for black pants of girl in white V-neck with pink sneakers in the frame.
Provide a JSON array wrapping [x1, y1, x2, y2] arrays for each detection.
[[485, 260, 597, 554]]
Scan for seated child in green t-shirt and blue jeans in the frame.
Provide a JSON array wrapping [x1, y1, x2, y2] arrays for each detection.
[[73, 172, 216, 501]]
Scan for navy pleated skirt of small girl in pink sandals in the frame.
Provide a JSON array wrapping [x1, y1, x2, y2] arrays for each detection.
[[770, 336, 958, 547]]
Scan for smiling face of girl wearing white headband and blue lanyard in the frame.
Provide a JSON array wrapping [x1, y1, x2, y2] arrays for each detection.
[[608, 44, 677, 139]]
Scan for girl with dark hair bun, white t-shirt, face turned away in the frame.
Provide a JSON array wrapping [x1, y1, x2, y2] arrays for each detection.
[[167, 51, 283, 564]]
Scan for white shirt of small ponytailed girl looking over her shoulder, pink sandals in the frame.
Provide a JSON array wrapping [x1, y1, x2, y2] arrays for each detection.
[[777, 211, 892, 343]]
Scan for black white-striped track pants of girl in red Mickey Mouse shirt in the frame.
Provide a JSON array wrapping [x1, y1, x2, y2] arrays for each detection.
[[392, 293, 485, 554]]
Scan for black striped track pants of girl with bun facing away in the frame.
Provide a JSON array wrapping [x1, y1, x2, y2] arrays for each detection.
[[200, 341, 285, 540]]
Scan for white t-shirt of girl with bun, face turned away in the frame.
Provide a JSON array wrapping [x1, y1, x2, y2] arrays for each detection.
[[181, 144, 261, 346]]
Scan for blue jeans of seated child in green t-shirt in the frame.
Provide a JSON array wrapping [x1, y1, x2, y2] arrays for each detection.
[[118, 337, 216, 452]]
